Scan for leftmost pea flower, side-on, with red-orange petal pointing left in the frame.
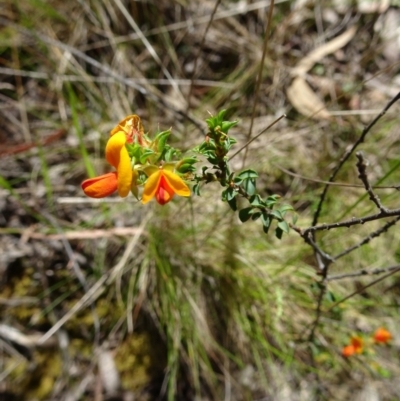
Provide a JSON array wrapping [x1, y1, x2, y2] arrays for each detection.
[[82, 131, 133, 198]]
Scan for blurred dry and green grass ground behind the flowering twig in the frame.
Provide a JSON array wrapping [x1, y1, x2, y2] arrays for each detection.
[[0, 0, 400, 401]]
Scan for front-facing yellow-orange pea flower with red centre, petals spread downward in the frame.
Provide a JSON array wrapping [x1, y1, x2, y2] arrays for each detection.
[[142, 169, 190, 205]]
